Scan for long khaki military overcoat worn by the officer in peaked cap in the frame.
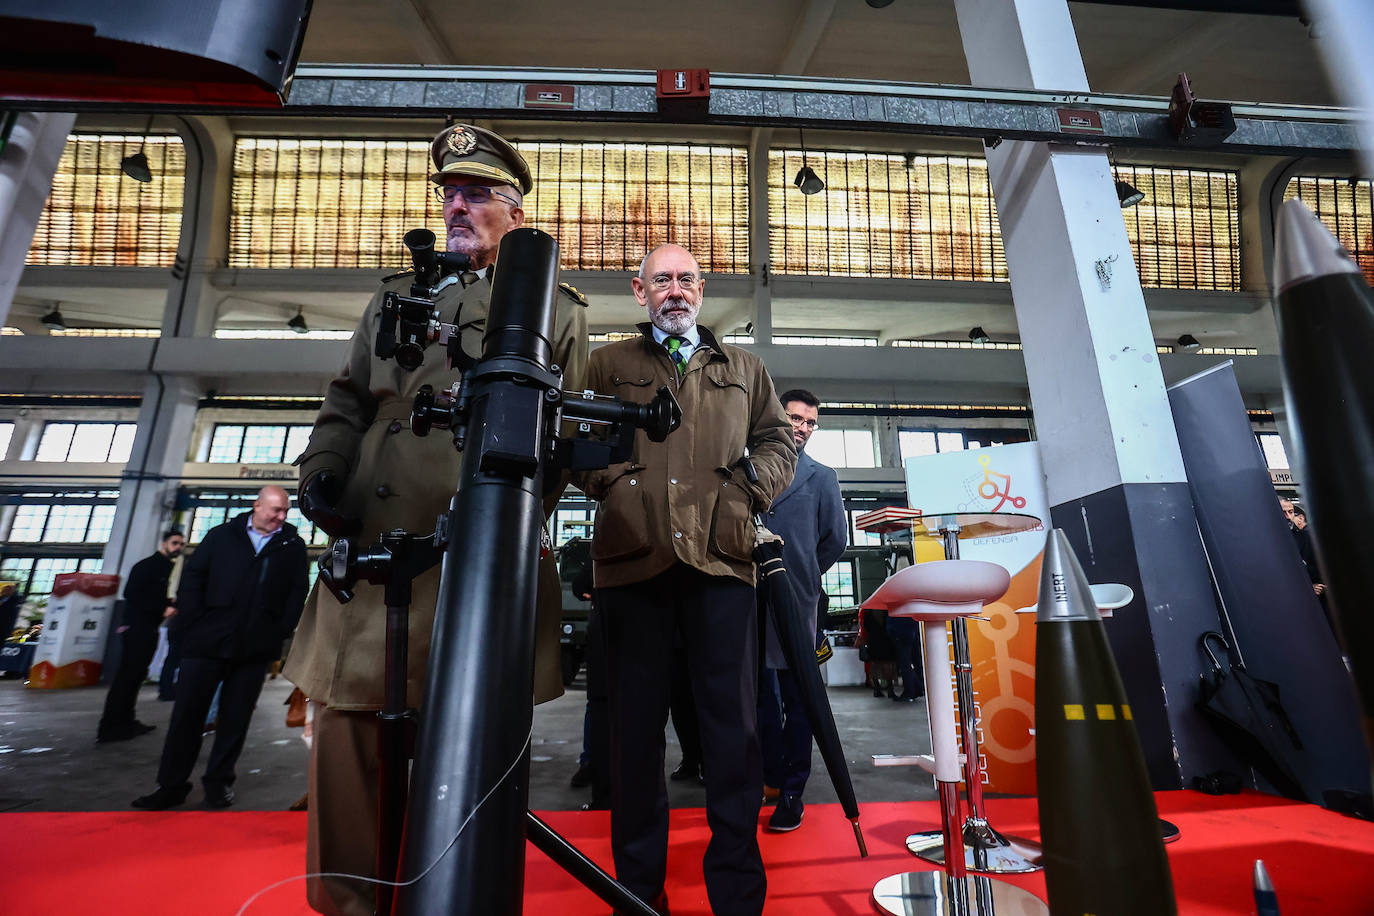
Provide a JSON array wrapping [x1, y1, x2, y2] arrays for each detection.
[[283, 272, 587, 710]]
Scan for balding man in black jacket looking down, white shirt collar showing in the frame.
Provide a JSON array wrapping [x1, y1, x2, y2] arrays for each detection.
[[133, 486, 306, 810]]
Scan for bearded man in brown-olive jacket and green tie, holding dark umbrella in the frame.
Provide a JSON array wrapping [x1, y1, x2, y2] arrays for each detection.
[[574, 244, 797, 916]]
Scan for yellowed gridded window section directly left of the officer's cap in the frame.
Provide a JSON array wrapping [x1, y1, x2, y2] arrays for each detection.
[[229, 137, 444, 269]]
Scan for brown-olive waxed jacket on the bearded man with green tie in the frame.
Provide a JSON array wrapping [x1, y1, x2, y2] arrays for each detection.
[[573, 323, 797, 588]]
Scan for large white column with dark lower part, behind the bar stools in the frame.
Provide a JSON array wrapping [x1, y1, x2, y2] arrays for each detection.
[[955, 0, 1232, 788]]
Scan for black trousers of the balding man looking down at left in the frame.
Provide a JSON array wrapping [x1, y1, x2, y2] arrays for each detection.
[[158, 658, 268, 788]]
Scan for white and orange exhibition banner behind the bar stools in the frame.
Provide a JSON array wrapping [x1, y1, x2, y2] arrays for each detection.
[[905, 442, 1050, 795]]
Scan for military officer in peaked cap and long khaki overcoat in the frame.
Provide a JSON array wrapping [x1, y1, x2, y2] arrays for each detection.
[[284, 125, 587, 915]]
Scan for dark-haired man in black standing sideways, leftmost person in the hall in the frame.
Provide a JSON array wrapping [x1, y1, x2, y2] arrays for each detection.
[[95, 529, 185, 742]]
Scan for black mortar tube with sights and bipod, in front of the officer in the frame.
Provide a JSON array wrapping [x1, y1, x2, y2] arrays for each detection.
[[330, 222, 682, 916]]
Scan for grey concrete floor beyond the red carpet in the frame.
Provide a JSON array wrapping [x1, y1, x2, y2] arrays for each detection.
[[0, 678, 934, 812]]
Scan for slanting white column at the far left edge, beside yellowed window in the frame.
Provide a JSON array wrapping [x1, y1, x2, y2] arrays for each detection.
[[0, 111, 77, 324]]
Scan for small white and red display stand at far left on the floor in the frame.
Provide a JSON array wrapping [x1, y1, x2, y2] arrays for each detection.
[[29, 573, 120, 688]]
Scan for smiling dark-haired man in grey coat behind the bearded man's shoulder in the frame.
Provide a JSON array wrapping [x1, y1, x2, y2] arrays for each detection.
[[758, 389, 849, 832]]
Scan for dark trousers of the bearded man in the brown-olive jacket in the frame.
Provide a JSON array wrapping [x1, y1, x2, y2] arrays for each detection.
[[598, 564, 767, 916]]
